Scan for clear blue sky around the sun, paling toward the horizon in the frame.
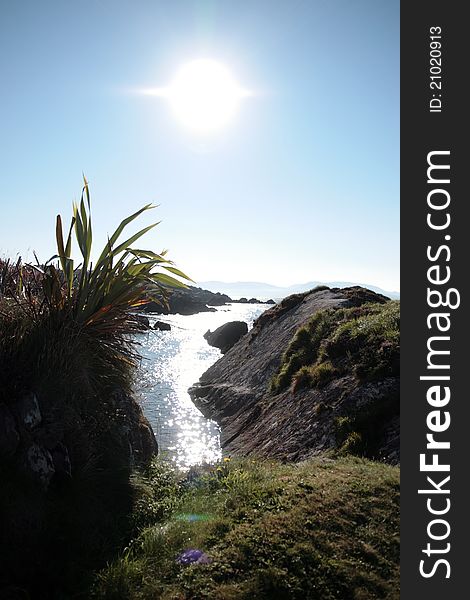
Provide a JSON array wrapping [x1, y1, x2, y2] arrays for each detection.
[[0, 0, 399, 290]]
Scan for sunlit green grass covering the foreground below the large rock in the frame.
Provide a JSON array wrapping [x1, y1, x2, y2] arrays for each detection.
[[93, 457, 399, 600]]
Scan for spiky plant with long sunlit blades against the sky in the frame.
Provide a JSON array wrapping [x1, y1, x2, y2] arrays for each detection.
[[44, 178, 192, 330]]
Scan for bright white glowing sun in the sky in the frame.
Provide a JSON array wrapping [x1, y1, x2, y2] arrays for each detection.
[[154, 59, 250, 133]]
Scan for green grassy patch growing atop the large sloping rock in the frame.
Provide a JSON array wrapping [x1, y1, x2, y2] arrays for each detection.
[[271, 302, 400, 393]]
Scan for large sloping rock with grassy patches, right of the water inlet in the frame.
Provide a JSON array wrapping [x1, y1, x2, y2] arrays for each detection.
[[190, 287, 399, 464]]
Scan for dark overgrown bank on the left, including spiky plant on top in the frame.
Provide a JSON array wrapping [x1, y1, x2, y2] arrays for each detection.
[[0, 181, 192, 597]]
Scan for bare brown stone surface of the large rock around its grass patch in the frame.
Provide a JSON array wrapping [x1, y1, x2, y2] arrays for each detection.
[[190, 287, 399, 463]]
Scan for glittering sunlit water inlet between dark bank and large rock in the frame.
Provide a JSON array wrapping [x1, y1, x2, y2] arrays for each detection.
[[136, 304, 269, 469]]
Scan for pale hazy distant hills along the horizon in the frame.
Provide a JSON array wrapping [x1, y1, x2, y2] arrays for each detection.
[[198, 281, 400, 300]]
